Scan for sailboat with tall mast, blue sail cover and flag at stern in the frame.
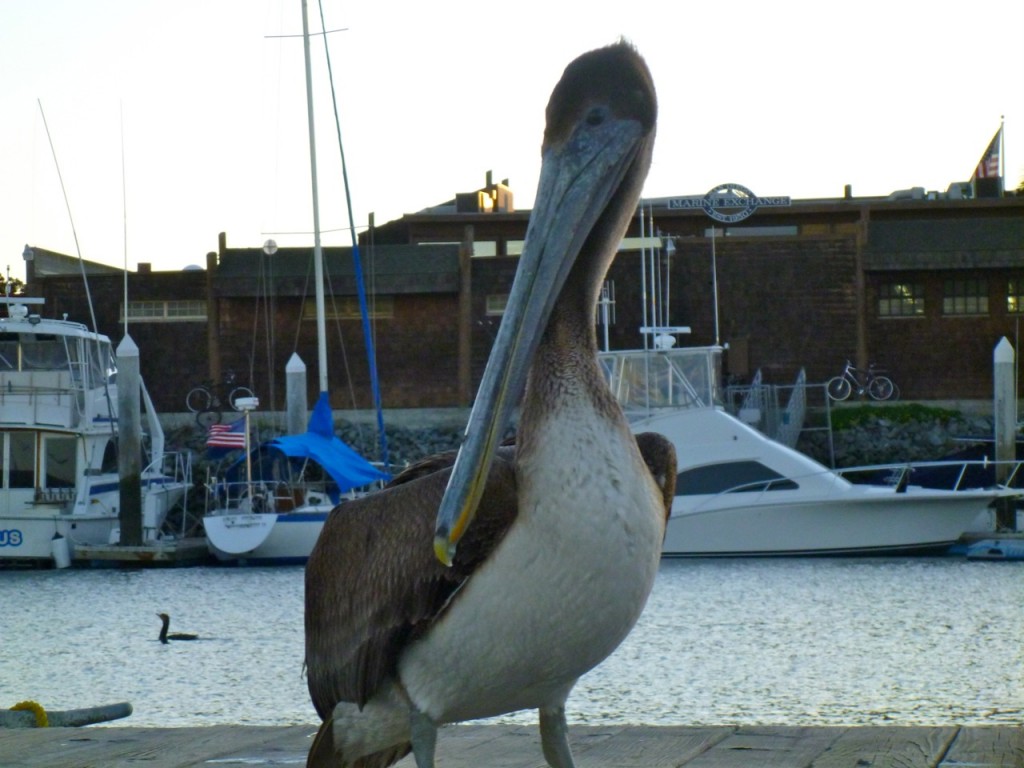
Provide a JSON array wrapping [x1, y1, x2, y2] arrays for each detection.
[[203, 0, 388, 564]]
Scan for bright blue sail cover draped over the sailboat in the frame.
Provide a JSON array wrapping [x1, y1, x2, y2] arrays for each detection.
[[267, 393, 390, 493]]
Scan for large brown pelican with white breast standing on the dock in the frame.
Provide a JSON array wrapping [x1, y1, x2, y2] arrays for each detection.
[[305, 42, 675, 768]]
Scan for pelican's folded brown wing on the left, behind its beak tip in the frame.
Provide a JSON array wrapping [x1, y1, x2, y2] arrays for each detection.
[[305, 449, 517, 719]]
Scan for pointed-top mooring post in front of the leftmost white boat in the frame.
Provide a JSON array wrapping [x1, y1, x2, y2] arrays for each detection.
[[117, 334, 142, 547]]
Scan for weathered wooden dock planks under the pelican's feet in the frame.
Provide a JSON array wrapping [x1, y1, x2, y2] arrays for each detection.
[[0, 725, 1024, 768]]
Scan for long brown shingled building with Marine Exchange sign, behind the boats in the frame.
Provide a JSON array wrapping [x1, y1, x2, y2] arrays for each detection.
[[27, 179, 1024, 411]]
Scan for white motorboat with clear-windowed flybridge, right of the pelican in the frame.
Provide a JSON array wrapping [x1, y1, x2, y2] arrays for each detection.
[[601, 347, 1020, 556]]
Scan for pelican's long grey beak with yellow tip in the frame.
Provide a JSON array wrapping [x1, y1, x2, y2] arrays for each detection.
[[434, 106, 644, 565]]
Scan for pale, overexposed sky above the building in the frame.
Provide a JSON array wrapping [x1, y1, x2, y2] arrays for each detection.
[[0, 0, 1024, 278]]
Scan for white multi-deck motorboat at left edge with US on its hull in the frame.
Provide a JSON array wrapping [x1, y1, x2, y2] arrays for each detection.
[[0, 296, 189, 566]]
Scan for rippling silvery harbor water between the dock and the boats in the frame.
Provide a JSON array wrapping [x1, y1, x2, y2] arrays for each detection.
[[0, 557, 1024, 726]]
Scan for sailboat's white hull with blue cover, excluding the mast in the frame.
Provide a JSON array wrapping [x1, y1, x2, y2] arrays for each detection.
[[203, 396, 388, 565]]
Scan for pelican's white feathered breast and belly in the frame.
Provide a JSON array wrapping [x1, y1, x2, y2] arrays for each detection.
[[399, 408, 664, 722]]
